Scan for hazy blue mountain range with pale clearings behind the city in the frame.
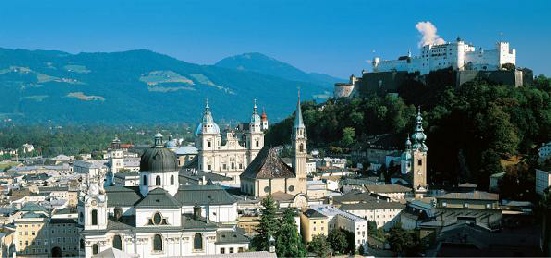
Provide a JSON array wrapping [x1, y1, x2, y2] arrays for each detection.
[[0, 49, 343, 124]]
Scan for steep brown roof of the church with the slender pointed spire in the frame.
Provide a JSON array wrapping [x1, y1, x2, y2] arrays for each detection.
[[241, 147, 295, 179]]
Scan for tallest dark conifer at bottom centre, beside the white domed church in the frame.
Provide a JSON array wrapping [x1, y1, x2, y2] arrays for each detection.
[[251, 195, 280, 251]]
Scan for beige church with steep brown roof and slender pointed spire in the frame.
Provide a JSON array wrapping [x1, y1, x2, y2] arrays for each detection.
[[241, 95, 307, 199]]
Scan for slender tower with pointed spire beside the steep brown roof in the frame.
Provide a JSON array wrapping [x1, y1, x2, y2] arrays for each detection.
[[293, 92, 306, 194]]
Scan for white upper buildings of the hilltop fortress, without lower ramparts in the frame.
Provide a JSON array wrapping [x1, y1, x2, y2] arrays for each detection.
[[372, 38, 516, 75]]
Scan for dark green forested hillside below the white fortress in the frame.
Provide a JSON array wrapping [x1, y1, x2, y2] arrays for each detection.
[[267, 75, 551, 198]]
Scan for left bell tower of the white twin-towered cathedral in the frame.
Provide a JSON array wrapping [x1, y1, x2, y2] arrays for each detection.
[[195, 100, 221, 172]]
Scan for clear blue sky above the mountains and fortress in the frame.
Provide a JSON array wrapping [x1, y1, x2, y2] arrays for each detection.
[[0, 0, 551, 78]]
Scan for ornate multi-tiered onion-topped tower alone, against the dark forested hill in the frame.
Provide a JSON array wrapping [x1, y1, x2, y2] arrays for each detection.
[[412, 107, 429, 196]]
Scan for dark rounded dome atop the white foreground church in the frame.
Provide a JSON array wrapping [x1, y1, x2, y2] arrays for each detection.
[[140, 134, 178, 172]]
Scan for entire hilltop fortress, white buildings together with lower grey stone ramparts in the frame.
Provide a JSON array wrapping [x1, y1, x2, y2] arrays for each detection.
[[334, 37, 533, 98]]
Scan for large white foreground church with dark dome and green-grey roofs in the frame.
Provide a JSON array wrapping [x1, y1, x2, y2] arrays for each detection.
[[77, 134, 249, 258]]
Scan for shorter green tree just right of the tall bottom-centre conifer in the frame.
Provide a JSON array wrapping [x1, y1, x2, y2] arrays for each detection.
[[276, 208, 306, 257]]
